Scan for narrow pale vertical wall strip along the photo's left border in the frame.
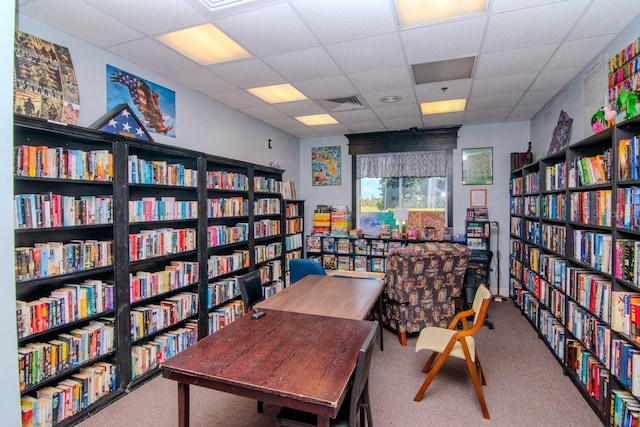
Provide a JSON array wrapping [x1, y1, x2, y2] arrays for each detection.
[[0, 1, 21, 426]]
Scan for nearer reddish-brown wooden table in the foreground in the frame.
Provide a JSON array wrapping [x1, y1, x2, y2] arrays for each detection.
[[161, 310, 374, 427]]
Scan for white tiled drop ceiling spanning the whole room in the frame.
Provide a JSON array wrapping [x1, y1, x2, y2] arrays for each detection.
[[17, 0, 640, 138]]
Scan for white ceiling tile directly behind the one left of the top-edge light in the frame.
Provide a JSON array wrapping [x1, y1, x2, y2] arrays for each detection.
[[327, 33, 405, 73]]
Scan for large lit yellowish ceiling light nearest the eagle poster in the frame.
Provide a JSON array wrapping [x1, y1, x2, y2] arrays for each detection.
[[156, 24, 251, 65]]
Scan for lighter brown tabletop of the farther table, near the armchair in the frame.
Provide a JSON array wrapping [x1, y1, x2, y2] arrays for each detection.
[[256, 274, 384, 319]]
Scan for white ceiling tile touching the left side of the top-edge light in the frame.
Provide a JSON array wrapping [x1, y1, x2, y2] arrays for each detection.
[[291, 0, 396, 43]]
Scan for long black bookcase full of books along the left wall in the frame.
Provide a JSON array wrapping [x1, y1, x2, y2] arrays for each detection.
[[13, 116, 284, 425]]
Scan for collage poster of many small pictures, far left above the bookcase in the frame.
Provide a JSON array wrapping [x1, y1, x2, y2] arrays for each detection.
[[13, 31, 80, 125]]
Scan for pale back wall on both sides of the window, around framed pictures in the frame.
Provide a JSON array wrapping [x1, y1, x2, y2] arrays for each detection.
[[299, 122, 530, 296]]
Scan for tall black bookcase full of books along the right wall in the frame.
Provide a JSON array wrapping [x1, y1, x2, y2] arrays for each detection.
[[510, 113, 640, 425]]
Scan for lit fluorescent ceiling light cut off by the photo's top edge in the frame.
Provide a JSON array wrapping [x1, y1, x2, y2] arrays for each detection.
[[396, 0, 487, 27]]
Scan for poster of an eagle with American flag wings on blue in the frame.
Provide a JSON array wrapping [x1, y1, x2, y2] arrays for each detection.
[[107, 64, 176, 138]]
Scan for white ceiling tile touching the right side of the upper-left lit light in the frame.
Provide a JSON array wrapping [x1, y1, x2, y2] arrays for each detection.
[[215, 3, 320, 56]]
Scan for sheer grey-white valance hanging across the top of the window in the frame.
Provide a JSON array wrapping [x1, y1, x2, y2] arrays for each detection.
[[356, 150, 447, 178]]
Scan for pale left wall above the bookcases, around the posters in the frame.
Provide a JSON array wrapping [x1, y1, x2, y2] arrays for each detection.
[[16, 14, 300, 181]]
